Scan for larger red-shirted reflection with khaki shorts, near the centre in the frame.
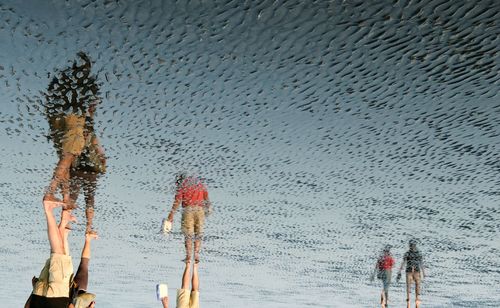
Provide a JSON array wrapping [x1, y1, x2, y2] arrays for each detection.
[[168, 174, 210, 263]]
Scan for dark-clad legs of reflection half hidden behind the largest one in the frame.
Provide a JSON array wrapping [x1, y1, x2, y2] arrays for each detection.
[[70, 170, 98, 232]]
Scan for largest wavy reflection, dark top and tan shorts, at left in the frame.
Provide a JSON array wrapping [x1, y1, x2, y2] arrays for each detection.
[[43, 53, 99, 209]]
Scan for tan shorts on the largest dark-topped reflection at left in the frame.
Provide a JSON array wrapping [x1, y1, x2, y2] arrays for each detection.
[[61, 114, 85, 156]]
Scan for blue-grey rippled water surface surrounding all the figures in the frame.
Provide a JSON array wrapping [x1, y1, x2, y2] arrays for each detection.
[[0, 0, 500, 308]]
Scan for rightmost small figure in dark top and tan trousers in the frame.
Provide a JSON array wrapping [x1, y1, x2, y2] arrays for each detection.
[[397, 239, 425, 308]]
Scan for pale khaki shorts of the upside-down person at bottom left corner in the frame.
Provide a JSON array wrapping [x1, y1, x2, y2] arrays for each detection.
[[33, 253, 73, 297]]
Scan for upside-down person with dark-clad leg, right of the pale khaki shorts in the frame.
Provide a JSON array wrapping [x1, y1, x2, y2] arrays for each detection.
[[68, 232, 97, 308]]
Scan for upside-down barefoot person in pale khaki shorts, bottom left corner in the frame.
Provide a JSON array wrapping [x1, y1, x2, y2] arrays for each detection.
[[25, 201, 75, 308]]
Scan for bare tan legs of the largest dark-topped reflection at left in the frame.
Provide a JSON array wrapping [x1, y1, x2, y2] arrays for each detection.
[[43, 152, 76, 209]]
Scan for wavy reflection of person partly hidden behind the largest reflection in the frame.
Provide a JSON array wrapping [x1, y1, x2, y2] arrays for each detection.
[[70, 105, 106, 232]]
